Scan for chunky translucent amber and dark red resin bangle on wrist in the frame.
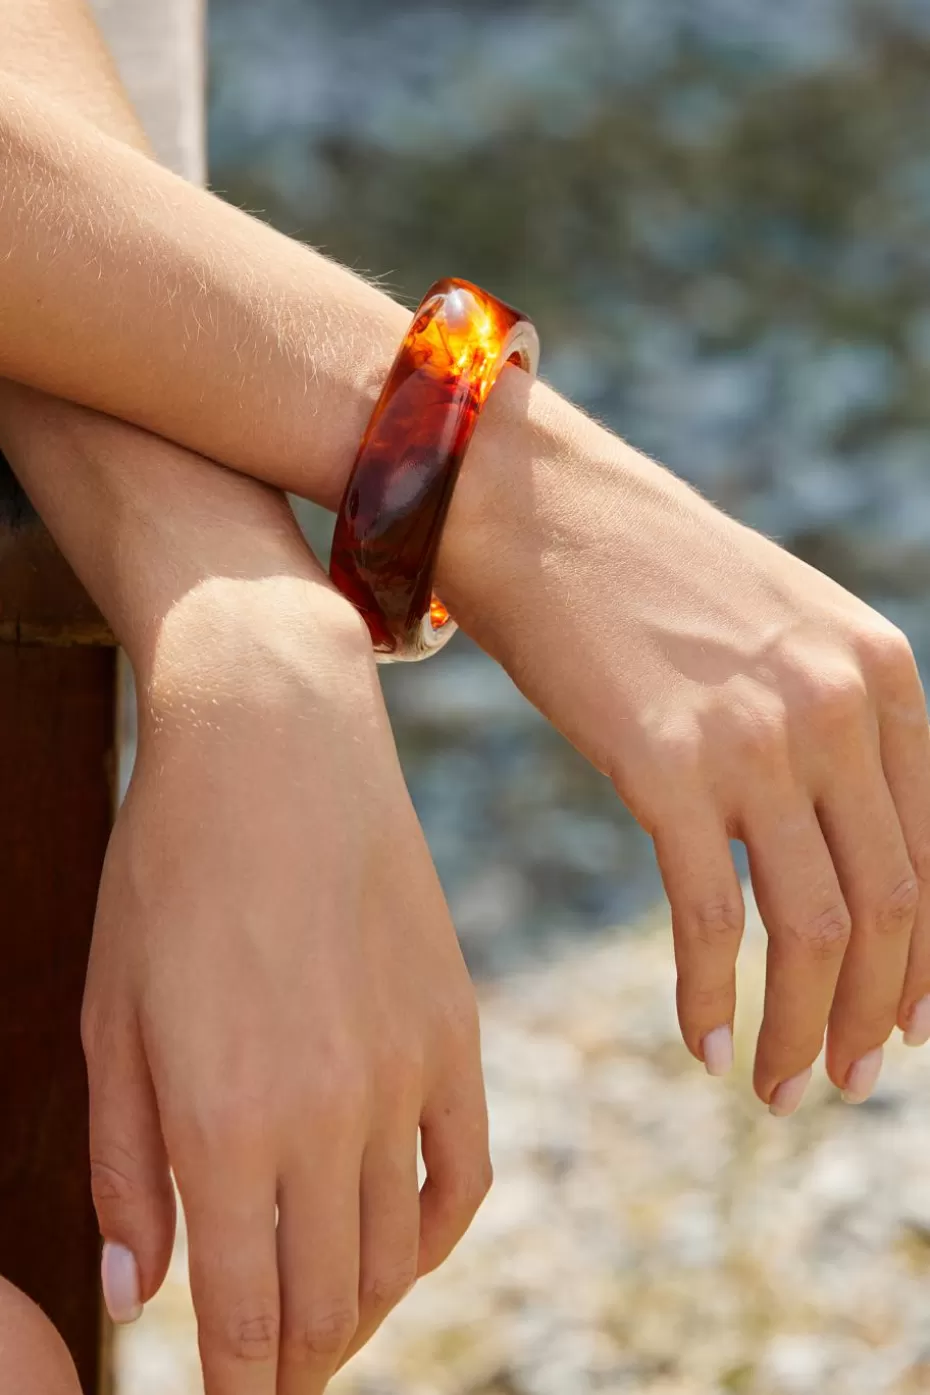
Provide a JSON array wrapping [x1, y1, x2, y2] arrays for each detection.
[[329, 279, 540, 663]]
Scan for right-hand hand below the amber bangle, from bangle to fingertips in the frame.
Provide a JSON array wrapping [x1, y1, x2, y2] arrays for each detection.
[[438, 374, 930, 1113]]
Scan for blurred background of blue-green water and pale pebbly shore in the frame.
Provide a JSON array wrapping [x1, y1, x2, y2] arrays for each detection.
[[120, 0, 930, 1395]]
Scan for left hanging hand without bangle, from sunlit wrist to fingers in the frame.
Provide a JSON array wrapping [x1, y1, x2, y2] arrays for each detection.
[[84, 541, 489, 1395]]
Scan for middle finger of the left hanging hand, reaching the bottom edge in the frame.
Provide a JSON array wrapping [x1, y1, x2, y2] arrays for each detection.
[[277, 1127, 361, 1395]]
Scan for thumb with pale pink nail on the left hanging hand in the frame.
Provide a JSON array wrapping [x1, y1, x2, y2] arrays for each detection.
[[84, 1013, 177, 1322]]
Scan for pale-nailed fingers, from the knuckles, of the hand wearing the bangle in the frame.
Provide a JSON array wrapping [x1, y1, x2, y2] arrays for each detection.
[[640, 615, 930, 1113]]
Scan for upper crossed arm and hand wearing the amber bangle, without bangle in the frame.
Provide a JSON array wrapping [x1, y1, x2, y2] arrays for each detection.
[[0, 0, 930, 1112]]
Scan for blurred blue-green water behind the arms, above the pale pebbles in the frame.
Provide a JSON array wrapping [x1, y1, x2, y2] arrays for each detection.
[[209, 0, 930, 970]]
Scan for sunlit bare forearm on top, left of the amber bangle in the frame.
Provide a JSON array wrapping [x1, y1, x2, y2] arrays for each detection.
[[0, 55, 407, 504]]
